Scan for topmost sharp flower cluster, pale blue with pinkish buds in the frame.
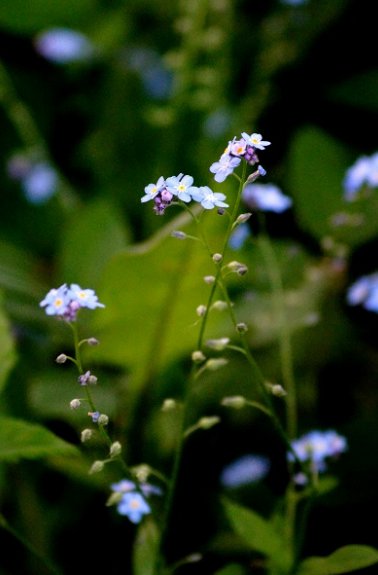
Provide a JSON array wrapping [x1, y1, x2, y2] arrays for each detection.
[[210, 132, 270, 182]]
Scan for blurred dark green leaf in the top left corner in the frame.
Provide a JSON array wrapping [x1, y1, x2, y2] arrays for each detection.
[[0, 0, 97, 33]]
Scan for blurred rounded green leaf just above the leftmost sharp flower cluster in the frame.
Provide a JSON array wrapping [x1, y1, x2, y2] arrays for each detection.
[[58, 200, 127, 287]]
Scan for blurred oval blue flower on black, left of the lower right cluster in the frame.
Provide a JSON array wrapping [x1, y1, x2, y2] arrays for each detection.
[[220, 454, 270, 488]]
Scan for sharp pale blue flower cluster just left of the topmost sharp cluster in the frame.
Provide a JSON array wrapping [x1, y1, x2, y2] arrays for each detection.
[[141, 174, 228, 215]]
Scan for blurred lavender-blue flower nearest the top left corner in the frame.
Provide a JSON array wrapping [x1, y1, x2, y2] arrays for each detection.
[[34, 28, 95, 64]]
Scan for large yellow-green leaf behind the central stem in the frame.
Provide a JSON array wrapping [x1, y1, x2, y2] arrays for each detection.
[[88, 209, 227, 376]]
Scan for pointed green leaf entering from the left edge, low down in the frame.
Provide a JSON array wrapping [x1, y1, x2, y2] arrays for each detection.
[[0, 417, 77, 461]]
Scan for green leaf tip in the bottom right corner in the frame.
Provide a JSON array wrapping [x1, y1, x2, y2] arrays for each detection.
[[297, 545, 378, 575]]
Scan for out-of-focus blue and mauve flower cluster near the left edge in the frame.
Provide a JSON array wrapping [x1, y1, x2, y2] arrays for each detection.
[[7, 154, 59, 204]]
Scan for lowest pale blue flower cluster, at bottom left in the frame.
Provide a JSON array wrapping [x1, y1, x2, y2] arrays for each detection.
[[111, 479, 161, 523]]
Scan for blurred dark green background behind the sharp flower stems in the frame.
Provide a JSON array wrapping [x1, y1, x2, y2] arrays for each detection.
[[0, 0, 378, 575]]
